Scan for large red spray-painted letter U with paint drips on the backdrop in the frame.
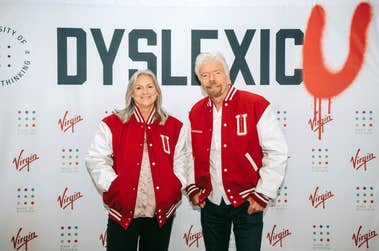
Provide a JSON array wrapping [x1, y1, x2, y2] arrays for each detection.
[[303, 3, 372, 140]]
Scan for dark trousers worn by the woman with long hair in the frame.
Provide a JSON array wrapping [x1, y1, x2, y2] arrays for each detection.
[[107, 217, 174, 251]]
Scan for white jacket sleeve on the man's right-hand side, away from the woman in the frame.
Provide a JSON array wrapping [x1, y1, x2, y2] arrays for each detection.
[[255, 105, 288, 199]]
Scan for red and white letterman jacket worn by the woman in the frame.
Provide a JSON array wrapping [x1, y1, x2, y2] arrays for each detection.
[[86, 107, 186, 229]]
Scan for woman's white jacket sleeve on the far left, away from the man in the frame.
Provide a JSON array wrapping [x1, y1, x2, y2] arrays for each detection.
[[85, 122, 117, 193]]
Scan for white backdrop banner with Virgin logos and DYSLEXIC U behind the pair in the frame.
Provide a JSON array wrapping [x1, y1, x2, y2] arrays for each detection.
[[0, 0, 379, 251]]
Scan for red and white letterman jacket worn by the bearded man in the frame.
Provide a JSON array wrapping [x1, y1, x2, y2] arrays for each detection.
[[186, 86, 288, 207]]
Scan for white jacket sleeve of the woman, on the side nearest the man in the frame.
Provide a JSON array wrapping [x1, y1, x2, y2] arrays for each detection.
[[174, 122, 191, 189]]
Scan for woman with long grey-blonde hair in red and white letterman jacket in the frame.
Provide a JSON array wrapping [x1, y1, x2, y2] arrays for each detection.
[[86, 70, 186, 251]]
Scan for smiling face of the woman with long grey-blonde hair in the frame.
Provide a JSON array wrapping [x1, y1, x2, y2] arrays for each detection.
[[132, 75, 158, 109]]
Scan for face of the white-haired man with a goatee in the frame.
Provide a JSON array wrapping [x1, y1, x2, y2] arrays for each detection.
[[199, 60, 230, 98]]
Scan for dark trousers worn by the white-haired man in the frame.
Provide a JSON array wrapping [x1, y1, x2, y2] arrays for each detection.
[[201, 200, 263, 251]]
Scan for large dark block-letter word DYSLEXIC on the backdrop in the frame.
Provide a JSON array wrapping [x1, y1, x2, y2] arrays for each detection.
[[57, 28, 304, 86]]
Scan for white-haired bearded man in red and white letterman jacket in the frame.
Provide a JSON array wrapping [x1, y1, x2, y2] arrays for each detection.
[[186, 53, 287, 251]]
